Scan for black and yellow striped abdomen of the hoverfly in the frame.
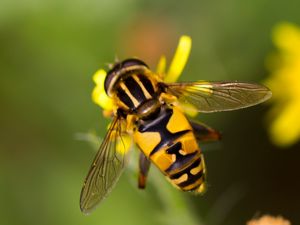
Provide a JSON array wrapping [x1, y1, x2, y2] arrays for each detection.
[[134, 107, 205, 192]]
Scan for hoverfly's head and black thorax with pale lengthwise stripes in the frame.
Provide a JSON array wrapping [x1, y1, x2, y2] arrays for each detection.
[[105, 59, 161, 119]]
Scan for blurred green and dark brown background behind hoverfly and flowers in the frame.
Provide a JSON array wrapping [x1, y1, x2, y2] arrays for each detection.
[[0, 0, 300, 225]]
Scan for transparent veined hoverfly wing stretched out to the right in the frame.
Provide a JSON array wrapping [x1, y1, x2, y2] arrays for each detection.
[[164, 81, 272, 113]]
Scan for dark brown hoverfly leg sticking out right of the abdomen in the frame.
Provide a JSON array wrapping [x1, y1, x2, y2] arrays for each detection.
[[190, 121, 221, 142]]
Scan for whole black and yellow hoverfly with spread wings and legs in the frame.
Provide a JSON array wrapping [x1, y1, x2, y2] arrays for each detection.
[[80, 58, 271, 213]]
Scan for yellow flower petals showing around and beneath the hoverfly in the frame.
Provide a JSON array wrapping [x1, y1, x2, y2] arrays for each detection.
[[92, 36, 196, 154]]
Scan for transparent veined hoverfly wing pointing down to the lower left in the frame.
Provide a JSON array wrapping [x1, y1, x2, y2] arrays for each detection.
[[80, 117, 126, 214]]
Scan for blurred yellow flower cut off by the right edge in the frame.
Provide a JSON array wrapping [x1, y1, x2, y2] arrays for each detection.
[[265, 23, 300, 147]]
